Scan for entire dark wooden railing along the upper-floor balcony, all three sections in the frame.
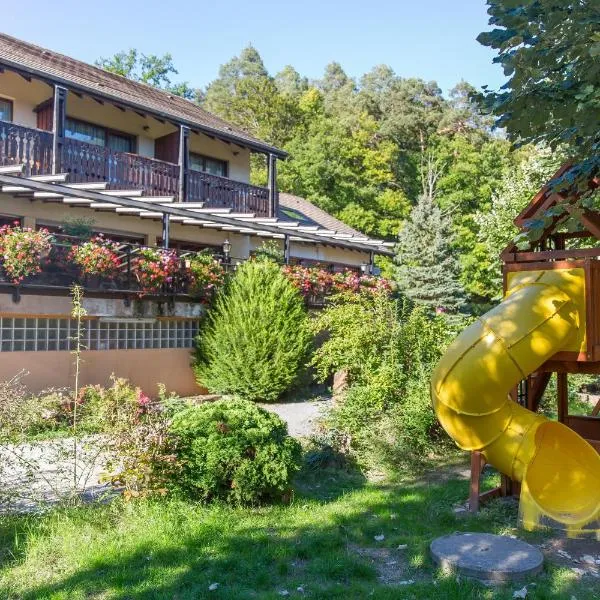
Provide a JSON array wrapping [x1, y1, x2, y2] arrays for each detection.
[[0, 121, 270, 216]]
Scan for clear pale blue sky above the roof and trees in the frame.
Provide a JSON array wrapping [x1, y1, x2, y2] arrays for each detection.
[[0, 0, 504, 96]]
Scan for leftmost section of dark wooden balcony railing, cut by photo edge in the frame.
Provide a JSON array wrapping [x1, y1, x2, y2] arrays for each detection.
[[0, 121, 52, 177]]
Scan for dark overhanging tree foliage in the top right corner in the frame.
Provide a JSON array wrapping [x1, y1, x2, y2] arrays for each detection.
[[478, 0, 600, 181]]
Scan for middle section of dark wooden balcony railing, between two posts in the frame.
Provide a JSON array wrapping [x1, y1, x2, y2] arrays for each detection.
[[60, 139, 179, 196]]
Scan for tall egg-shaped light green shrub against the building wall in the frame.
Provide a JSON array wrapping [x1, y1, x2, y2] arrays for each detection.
[[195, 261, 311, 402]]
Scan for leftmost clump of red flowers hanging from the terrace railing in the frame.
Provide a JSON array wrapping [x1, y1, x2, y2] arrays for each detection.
[[0, 223, 52, 284]]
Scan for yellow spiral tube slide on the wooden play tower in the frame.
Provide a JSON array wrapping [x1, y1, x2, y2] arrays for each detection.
[[431, 268, 600, 539]]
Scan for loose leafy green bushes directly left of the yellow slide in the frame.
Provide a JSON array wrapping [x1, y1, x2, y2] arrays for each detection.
[[312, 296, 452, 469]]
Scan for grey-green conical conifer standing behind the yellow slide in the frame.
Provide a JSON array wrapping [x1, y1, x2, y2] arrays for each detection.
[[395, 192, 464, 313]]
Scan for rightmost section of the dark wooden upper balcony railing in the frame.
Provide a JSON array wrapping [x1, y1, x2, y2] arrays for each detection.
[[188, 171, 269, 217]]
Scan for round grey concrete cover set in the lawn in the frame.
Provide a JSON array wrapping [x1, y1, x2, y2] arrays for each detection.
[[431, 533, 544, 582]]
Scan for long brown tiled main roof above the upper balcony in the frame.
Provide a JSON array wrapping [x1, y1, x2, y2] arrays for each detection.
[[0, 33, 285, 156]]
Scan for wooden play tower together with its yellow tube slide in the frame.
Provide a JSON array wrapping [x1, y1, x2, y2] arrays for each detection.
[[431, 166, 600, 539]]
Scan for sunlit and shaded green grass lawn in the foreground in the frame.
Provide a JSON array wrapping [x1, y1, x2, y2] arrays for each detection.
[[0, 470, 600, 600]]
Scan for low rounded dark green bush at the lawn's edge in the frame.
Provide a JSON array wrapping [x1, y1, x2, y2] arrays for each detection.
[[170, 400, 301, 504]]
